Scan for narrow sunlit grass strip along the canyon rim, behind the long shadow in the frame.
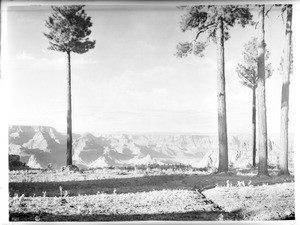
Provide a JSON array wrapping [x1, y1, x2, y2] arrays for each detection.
[[9, 165, 215, 182]]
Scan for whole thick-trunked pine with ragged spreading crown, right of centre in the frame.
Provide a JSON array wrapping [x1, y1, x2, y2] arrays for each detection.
[[177, 5, 252, 172]]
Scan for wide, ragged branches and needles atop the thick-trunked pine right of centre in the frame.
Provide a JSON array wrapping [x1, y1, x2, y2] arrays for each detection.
[[176, 5, 252, 57]]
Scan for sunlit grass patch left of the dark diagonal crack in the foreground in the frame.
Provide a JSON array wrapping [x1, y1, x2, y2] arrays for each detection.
[[9, 190, 223, 219]]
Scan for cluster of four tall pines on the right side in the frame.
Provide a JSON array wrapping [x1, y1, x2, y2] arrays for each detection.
[[177, 4, 292, 176]]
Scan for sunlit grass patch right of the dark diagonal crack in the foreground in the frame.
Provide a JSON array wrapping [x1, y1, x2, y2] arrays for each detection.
[[203, 183, 295, 221]]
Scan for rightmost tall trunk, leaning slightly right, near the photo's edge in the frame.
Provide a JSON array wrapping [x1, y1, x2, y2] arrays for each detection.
[[278, 5, 293, 175]]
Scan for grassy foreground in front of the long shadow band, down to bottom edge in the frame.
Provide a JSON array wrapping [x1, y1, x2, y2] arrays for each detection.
[[9, 182, 295, 221]]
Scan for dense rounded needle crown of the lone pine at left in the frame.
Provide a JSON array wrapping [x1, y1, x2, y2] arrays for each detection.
[[44, 5, 95, 54]]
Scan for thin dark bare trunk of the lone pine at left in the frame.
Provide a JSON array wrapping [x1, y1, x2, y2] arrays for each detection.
[[67, 52, 72, 166]]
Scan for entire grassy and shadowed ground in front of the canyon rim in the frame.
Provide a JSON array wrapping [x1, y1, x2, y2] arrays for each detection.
[[9, 169, 295, 221]]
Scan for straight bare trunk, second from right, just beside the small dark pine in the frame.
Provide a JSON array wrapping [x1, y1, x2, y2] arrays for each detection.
[[257, 5, 269, 176]]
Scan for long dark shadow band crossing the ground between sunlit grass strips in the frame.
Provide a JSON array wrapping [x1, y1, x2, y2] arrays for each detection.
[[9, 174, 294, 197]]
